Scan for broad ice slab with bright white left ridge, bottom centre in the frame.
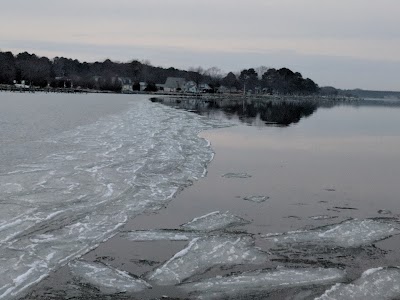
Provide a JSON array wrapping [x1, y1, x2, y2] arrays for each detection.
[[147, 236, 267, 285]]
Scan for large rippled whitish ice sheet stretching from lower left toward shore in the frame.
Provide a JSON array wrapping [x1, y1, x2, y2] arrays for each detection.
[[0, 99, 228, 299]]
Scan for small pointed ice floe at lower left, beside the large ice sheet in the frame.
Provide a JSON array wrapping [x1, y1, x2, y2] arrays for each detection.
[[69, 261, 151, 294]]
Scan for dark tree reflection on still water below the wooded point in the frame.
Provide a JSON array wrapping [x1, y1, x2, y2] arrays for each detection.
[[150, 97, 400, 127]]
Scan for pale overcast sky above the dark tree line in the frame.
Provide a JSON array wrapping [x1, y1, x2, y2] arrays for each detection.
[[0, 0, 400, 90]]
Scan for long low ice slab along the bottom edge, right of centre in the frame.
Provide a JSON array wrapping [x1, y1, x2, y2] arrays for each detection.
[[180, 268, 350, 299]]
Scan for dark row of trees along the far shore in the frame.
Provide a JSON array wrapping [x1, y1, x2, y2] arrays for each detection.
[[0, 52, 319, 94]]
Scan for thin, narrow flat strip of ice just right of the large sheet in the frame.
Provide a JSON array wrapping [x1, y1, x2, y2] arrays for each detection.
[[123, 230, 201, 242]]
